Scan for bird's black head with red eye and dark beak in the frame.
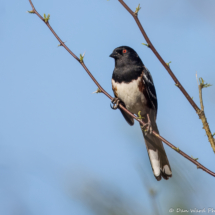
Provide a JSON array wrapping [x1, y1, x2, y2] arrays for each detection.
[[110, 46, 143, 67]]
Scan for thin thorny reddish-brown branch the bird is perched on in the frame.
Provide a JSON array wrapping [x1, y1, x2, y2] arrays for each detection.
[[29, 0, 215, 177]]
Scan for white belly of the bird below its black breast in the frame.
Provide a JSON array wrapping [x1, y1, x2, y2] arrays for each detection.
[[112, 78, 148, 115]]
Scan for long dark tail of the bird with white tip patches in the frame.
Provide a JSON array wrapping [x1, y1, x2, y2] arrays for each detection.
[[143, 114, 172, 181]]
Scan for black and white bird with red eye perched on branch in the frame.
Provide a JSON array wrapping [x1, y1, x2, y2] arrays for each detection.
[[110, 46, 172, 181]]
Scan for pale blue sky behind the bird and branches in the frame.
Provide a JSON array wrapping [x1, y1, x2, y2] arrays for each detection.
[[0, 0, 215, 215]]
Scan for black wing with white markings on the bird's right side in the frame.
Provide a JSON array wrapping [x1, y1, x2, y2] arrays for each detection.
[[143, 67, 158, 115]]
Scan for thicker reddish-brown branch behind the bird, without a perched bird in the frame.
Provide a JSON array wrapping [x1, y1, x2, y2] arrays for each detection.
[[118, 0, 215, 153]]
